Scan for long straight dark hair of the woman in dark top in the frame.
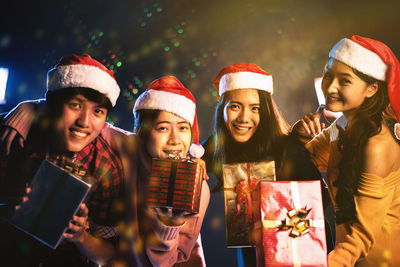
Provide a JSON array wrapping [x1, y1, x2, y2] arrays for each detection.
[[212, 90, 289, 192]]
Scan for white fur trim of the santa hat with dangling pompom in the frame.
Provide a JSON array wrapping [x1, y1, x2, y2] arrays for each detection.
[[133, 89, 196, 125]]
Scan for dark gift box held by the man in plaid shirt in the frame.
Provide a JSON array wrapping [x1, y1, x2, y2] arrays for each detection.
[[9, 160, 94, 249]]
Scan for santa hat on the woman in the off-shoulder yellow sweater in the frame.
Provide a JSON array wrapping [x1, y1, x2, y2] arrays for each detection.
[[329, 35, 400, 121]]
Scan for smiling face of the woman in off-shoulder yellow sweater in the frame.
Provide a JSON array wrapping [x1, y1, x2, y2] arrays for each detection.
[[321, 59, 378, 117]]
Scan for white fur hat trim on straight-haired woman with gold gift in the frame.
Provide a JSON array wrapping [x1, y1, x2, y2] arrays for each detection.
[[219, 72, 274, 95]]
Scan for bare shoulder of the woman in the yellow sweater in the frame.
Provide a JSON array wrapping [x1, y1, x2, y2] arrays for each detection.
[[364, 125, 400, 177]]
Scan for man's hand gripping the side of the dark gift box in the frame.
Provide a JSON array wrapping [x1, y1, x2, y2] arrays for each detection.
[[63, 204, 89, 243]]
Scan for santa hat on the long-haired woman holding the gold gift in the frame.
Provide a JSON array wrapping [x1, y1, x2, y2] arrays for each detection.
[[213, 63, 274, 96]]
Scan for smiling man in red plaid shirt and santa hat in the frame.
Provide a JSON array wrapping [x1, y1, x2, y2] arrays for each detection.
[[0, 55, 123, 266]]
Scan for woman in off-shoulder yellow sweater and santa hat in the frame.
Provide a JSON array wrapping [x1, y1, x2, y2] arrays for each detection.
[[294, 35, 400, 267]]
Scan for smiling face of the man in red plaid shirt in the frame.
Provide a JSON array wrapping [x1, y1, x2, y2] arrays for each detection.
[[55, 94, 107, 152]]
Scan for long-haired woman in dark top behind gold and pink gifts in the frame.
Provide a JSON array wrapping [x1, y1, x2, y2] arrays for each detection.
[[202, 63, 333, 266]]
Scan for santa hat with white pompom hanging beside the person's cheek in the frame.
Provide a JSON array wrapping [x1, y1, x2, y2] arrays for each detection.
[[133, 76, 204, 158]]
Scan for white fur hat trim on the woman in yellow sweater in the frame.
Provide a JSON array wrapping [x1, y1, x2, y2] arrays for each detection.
[[329, 38, 387, 81]]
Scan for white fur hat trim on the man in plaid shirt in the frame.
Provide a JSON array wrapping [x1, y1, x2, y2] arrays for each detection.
[[47, 64, 120, 106]]
